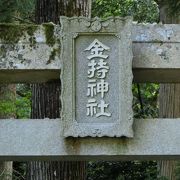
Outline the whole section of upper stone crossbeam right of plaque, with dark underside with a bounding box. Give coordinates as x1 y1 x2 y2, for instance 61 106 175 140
133 24 180 83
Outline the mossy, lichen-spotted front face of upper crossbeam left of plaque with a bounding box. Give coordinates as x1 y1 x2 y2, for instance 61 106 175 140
0 24 61 70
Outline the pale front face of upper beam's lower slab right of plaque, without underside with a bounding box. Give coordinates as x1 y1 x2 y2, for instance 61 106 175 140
133 42 180 69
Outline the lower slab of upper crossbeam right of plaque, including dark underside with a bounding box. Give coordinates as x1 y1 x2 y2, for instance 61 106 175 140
133 42 180 83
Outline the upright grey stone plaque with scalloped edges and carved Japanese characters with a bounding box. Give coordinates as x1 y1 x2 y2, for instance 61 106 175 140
60 17 133 137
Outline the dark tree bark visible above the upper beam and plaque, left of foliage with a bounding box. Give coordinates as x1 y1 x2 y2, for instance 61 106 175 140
36 0 91 24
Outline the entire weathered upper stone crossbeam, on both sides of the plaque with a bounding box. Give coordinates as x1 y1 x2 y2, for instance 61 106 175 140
0 23 180 83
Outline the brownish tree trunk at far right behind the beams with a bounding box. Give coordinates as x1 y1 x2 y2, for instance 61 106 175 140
158 1 180 180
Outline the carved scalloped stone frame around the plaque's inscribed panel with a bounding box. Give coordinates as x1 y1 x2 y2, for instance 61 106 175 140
60 16 133 138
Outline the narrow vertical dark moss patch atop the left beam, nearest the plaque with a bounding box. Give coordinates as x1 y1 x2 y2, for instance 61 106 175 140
43 23 56 46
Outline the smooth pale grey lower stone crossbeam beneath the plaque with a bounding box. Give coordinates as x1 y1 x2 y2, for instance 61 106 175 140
0 119 180 161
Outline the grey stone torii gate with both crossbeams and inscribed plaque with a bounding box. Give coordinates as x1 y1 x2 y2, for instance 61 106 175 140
0 17 180 161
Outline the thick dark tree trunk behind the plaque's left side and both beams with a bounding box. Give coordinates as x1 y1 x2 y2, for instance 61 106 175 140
26 0 91 180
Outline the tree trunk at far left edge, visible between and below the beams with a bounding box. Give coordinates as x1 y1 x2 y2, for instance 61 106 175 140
0 85 16 180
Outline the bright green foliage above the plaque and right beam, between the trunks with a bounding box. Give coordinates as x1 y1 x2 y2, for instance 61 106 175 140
92 0 159 22
